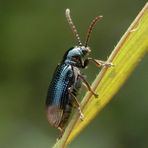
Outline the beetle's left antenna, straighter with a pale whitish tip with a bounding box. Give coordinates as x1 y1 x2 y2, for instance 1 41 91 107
65 9 82 46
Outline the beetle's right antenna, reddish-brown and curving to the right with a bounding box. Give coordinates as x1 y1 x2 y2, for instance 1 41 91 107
84 16 103 47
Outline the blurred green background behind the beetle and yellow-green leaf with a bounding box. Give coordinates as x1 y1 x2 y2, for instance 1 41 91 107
0 0 148 148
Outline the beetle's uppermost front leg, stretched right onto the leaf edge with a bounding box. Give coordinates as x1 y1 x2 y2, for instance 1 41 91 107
88 58 114 67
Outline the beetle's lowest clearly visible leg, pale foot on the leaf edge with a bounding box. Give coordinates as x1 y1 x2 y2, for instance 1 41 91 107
68 88 84 120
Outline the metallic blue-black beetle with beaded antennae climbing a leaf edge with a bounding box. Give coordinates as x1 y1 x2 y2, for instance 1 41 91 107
46 9 112 132
